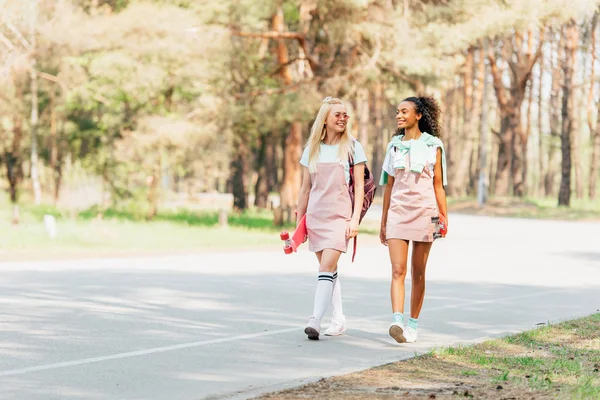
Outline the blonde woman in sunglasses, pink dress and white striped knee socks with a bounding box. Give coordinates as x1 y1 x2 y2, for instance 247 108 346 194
297 97 367 340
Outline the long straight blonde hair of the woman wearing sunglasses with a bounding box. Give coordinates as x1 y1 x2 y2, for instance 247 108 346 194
306 97 355 173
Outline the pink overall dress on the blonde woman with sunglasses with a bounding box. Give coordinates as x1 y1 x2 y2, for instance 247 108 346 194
306 162 352 253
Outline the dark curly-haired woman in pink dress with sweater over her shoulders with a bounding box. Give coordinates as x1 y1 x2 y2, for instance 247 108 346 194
379 97 448 343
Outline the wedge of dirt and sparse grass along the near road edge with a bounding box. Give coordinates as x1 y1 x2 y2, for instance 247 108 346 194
252 314 600 400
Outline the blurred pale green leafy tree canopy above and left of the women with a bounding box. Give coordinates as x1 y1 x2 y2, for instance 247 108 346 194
0 0 599 216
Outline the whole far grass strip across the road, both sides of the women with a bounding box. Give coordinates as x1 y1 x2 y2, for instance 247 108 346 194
0 191 600 260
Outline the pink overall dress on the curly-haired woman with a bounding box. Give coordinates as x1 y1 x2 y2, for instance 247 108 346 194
386 154 438 242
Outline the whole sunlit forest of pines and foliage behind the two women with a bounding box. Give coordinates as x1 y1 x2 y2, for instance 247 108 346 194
0 0 600 244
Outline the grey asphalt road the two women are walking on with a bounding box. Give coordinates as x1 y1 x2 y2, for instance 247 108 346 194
0 215 600 400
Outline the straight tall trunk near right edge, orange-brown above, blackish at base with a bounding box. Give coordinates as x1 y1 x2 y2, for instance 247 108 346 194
558 19 579 206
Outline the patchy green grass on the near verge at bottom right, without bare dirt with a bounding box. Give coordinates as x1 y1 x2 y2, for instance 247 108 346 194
436 313 600 399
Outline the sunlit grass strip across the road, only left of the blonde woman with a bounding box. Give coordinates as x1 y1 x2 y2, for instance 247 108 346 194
0 202 304 259
